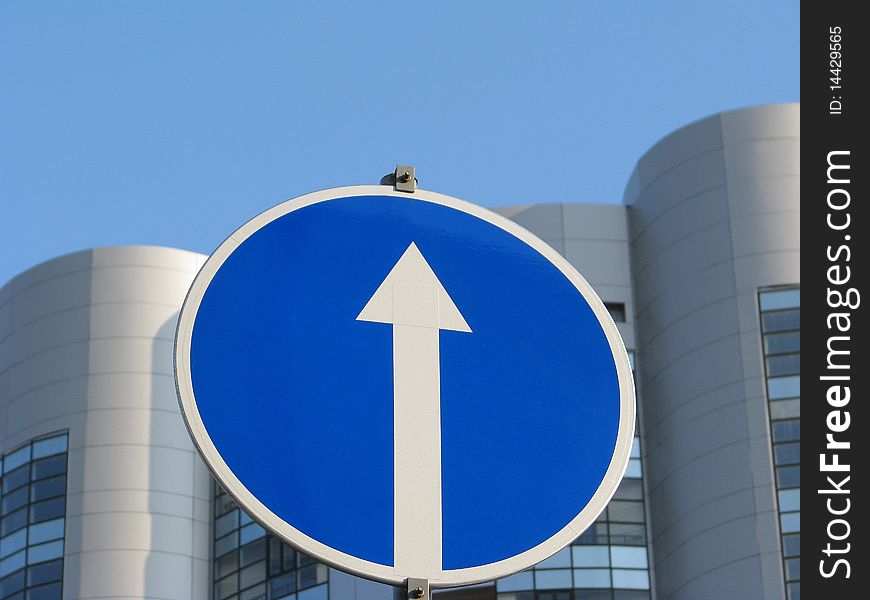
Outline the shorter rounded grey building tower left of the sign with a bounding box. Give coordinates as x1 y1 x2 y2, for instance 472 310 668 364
0 246 212 600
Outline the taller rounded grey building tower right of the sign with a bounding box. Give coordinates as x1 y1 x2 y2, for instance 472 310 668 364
625 104 800 600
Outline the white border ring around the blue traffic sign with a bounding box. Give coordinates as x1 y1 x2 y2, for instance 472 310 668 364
173 185 635 587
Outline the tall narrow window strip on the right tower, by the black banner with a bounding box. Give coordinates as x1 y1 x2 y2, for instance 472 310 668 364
758 286 801 600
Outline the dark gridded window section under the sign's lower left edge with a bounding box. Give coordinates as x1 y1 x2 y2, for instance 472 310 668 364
214 483 329 600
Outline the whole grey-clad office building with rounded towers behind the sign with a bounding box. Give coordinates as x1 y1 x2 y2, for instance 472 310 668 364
0 104 800 600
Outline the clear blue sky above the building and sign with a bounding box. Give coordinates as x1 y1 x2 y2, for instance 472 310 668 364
0 0 799 284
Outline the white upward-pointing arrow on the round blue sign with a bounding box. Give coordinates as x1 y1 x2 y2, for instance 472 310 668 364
357 243 471 578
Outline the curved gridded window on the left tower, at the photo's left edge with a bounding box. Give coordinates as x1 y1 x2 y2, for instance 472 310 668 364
0 433 68 600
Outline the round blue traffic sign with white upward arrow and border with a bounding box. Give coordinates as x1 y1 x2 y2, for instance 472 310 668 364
176 186 634 586
